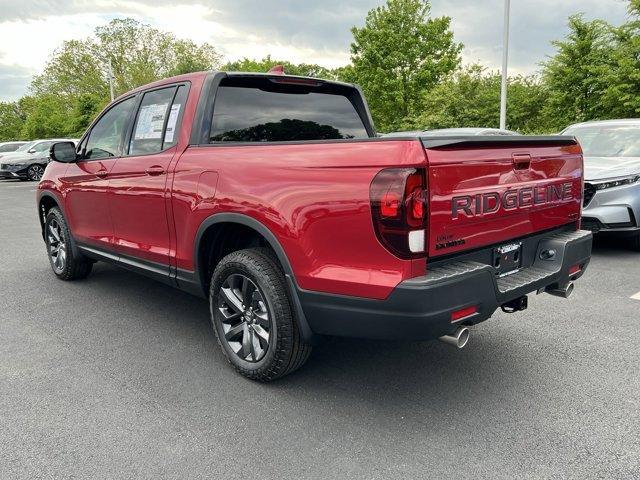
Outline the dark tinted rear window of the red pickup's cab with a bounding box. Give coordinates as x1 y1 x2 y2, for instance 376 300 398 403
210 86 368 142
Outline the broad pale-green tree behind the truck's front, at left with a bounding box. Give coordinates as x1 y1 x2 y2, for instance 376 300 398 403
21 18 221 138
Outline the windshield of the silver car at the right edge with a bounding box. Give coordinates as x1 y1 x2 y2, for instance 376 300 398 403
563 125 640 157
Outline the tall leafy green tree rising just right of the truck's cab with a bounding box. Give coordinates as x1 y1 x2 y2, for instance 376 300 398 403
348 0 462 131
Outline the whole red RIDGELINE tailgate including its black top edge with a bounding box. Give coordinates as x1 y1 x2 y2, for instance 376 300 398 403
422 136 583 257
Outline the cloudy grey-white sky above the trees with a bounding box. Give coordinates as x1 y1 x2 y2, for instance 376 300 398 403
0 0 627 100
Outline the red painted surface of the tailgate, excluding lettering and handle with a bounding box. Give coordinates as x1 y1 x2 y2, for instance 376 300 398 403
427 146 582 256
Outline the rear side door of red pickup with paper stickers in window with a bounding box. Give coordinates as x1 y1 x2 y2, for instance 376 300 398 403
109 85 188 268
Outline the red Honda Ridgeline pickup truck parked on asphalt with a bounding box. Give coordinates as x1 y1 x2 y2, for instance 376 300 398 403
37 71 591 381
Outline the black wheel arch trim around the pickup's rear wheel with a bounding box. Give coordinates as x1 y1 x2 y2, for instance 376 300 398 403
190 213 318 344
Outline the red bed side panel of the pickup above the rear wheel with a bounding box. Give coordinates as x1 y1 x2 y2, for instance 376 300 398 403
172 139 425 298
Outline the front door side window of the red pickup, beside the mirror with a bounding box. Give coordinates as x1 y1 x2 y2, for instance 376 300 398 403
84 97 136 159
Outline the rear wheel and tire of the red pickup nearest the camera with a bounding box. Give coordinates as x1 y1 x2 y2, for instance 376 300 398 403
209 248 312 382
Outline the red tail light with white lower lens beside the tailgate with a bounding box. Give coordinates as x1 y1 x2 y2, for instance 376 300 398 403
369 168 427 259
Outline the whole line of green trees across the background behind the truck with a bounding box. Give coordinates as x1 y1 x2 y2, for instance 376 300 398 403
0 0 640 141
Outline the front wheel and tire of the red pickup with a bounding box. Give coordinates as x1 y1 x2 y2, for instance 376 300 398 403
44 207 93 280
